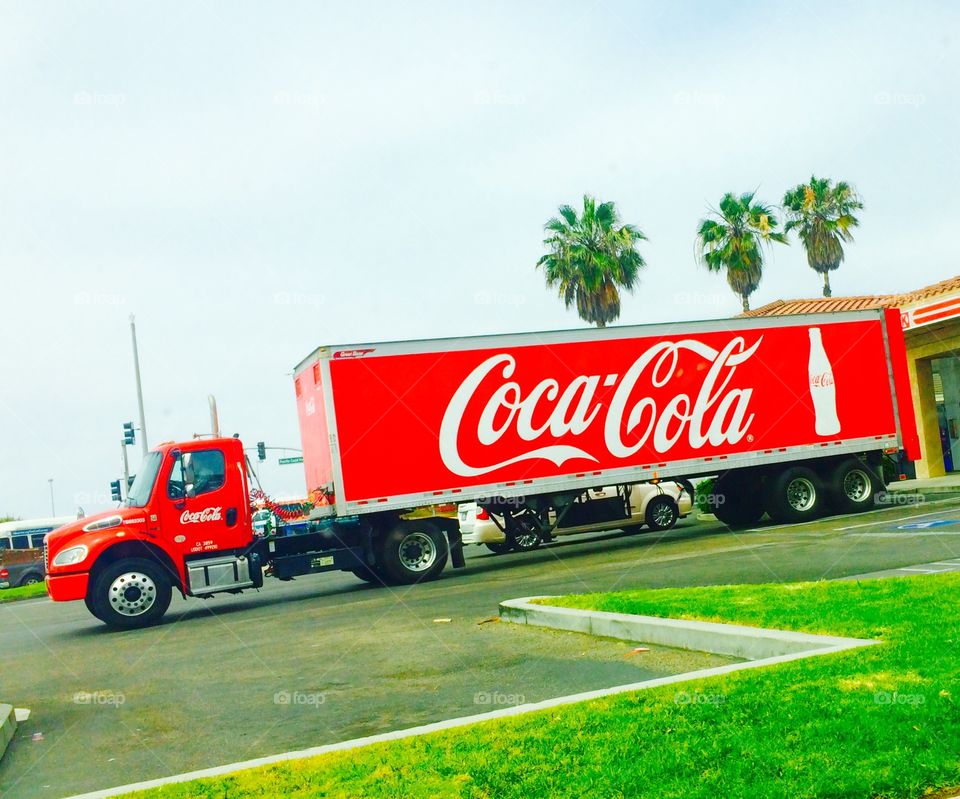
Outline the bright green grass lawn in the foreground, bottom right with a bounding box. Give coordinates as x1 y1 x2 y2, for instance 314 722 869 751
124 574 960 799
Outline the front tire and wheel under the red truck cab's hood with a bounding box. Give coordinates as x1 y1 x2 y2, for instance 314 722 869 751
87 558 172 630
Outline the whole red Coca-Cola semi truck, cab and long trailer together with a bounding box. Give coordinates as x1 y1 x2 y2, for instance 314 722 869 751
45 311 918 628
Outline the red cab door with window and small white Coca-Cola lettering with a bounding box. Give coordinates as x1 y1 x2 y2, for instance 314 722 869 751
160 446 251 556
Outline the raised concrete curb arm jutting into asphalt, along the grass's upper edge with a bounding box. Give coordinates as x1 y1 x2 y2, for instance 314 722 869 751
500 597 877 660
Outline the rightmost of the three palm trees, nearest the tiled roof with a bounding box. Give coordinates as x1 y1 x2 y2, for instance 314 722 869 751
783 176 863 297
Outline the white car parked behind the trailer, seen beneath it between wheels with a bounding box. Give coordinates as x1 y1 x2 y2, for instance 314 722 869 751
457 480 693 554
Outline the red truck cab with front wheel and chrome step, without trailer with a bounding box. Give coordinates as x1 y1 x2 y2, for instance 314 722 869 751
45 438 262 627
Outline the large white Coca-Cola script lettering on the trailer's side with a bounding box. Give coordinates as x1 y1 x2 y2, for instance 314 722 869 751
440 336 763 477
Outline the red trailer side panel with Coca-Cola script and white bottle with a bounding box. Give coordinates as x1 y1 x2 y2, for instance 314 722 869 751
330 320 895 502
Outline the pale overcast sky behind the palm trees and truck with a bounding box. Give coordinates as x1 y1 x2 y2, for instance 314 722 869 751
0 0 960 518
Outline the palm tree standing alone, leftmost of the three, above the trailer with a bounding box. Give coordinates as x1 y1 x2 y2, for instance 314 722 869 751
537 194 647 327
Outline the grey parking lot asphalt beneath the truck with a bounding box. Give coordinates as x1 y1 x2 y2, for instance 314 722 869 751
0 499 960 799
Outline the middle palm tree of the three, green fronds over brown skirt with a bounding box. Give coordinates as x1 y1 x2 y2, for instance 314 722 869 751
697 192 787 311
